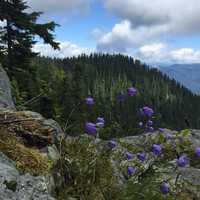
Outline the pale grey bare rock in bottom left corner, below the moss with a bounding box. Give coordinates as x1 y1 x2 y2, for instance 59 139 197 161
0 154 55 200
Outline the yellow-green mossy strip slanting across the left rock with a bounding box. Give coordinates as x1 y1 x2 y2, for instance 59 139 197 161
0 128 52 176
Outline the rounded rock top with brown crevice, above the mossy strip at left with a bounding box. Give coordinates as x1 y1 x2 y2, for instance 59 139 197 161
0 110 63 149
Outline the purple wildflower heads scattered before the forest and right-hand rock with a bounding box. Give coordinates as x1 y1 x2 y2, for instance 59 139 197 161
81 87 200 195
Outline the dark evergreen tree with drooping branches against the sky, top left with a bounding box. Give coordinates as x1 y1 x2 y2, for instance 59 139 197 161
0 0 59 72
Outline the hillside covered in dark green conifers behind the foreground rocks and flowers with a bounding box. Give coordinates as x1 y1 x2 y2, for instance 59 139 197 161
10 54 200 137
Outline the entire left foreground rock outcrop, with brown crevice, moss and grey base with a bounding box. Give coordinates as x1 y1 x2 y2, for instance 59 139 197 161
0 109 63 200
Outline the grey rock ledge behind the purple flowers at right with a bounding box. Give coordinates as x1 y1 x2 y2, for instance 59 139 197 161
111 129 200 199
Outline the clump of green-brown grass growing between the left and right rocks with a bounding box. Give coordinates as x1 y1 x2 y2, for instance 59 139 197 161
57 136 119 200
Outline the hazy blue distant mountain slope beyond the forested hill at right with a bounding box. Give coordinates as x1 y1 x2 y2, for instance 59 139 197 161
159 63 200 94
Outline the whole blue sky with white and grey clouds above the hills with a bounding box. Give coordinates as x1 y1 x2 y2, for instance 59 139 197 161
27 0 200 64
